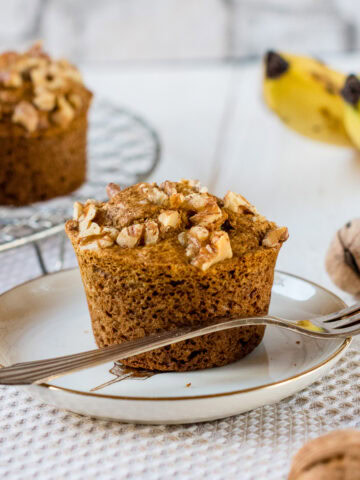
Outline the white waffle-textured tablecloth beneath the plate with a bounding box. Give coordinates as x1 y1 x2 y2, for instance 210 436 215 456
0 239 360 480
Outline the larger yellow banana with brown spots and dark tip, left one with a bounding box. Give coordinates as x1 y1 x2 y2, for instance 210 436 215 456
264 51 352 146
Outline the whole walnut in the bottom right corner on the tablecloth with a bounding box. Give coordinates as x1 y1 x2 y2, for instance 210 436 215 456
289 430 360 480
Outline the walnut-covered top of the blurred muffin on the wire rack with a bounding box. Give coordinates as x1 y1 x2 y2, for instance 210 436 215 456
0 43 92 135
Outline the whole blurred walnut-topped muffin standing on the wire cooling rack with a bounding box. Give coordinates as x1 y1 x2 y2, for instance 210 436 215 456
0 43 92 206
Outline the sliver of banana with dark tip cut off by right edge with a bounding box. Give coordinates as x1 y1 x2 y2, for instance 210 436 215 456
341 75 360 150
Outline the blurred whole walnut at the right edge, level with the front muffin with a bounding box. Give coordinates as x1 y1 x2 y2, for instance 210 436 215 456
325 218 360 296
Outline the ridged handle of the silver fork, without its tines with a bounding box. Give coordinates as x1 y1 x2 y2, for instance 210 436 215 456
0 316 276 385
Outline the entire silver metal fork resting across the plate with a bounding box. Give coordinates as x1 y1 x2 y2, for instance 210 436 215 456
0 303 360 385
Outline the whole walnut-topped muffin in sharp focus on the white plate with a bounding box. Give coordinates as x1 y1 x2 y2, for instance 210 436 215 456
66 180 288 371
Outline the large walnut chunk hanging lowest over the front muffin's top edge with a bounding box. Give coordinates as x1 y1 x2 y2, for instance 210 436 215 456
191 231 232 271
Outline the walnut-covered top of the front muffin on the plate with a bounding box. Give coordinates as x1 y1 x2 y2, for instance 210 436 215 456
67 180 288 271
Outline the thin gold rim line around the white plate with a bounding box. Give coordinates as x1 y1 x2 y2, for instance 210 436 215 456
0 268 351 402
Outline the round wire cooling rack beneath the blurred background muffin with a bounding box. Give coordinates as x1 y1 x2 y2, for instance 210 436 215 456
0 100 160 255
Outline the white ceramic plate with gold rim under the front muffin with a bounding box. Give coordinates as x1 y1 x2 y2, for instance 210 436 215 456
0 270 350 424
